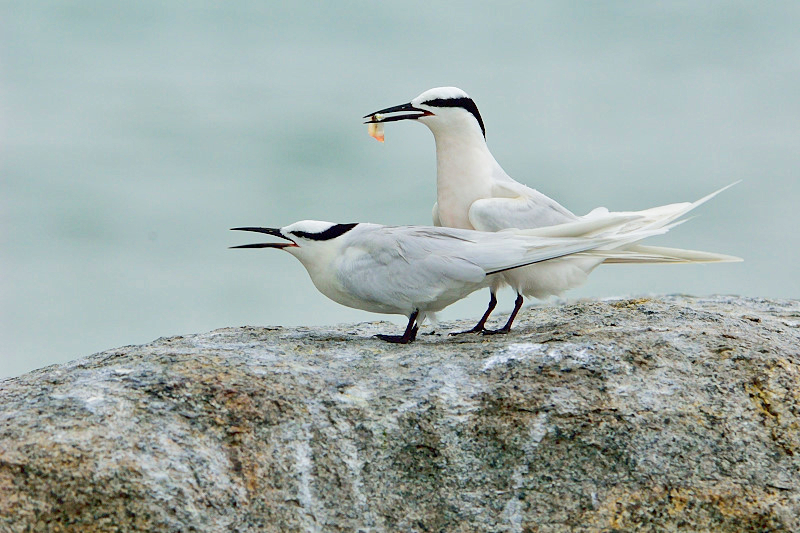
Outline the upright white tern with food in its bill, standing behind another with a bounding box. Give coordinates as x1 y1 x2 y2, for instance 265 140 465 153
364 87 741 334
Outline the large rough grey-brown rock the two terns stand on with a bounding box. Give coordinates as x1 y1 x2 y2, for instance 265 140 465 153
0 296 800 532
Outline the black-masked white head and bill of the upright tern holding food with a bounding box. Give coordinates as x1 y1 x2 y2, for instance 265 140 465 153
364 87 486 139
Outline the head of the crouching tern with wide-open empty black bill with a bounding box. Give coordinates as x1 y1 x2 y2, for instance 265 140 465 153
231 220 358 261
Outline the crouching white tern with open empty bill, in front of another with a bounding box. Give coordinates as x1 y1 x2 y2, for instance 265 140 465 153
232 215 669 343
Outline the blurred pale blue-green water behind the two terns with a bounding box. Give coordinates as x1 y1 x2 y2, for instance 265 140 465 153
0 0 800 377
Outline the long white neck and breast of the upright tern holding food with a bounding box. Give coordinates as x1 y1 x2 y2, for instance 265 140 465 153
432 128 502 229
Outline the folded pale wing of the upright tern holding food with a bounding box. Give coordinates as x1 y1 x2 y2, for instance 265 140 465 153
469 182 578 231
